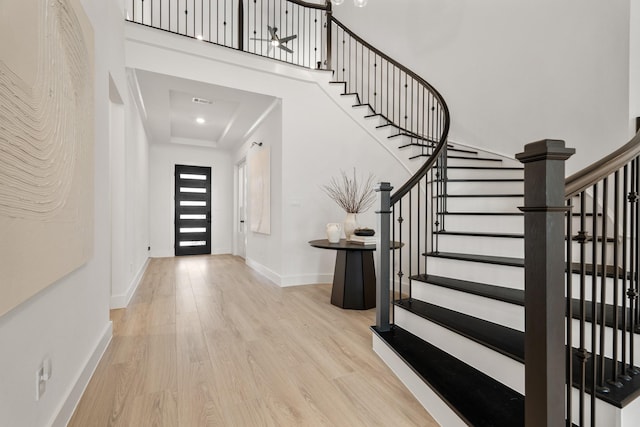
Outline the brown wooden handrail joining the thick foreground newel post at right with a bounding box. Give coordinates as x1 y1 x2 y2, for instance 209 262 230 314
564 130 640 199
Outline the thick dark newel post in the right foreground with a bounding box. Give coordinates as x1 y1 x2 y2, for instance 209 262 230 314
516 139 575 427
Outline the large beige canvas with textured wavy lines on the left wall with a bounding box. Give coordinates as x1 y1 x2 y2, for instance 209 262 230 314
0 0 94 316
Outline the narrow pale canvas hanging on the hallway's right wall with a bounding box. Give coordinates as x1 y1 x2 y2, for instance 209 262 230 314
248 146 271 234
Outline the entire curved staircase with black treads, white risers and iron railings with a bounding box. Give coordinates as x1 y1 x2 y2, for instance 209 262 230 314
128 0 640 427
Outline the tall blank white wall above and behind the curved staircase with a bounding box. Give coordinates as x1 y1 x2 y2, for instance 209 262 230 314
334 0 637 172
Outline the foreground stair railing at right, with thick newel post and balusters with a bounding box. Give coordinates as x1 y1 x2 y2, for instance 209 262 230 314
517 120 640 427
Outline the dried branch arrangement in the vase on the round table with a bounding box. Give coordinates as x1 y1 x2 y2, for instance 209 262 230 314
322 169 376 213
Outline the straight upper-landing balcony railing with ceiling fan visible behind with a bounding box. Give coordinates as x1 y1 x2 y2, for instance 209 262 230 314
126 0 331 69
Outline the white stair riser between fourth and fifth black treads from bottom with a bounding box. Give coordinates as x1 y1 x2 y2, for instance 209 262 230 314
436 234 524 258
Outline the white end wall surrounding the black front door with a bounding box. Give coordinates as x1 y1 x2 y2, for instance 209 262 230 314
149 143 233 257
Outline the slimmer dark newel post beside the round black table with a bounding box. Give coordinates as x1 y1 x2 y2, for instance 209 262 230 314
375 182 393 331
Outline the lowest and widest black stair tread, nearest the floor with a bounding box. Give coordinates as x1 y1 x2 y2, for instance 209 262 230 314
372 326 524 427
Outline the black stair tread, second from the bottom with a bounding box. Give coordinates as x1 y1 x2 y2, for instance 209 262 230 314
396 299 524 363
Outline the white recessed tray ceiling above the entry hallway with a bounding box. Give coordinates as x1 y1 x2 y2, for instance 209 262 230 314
129 70 276 149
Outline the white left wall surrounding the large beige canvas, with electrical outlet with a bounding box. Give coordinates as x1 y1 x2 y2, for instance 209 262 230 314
0 1 126 426
